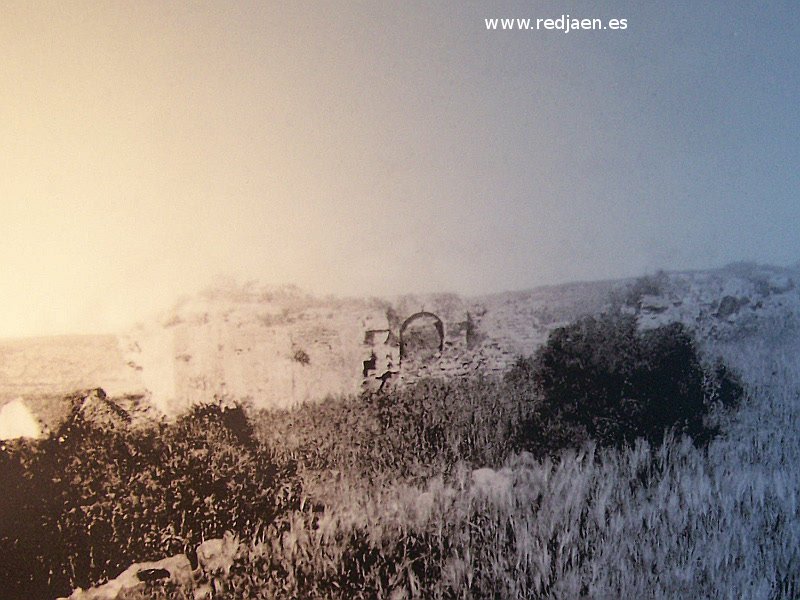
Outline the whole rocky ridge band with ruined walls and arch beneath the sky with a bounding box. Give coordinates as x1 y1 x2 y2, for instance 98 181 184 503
0 263 800 436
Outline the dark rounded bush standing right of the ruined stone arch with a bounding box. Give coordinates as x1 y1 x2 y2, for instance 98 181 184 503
507 312 742 454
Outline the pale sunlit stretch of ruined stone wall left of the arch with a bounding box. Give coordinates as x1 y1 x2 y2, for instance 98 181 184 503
125 302 394 413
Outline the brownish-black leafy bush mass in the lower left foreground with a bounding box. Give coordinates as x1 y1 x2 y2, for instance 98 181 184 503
0 398 299 598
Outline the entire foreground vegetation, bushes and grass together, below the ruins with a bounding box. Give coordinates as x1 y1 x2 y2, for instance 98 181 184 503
0 304 800 600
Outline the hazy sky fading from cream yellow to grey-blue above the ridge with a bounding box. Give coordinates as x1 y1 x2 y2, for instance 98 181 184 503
0 0 800 337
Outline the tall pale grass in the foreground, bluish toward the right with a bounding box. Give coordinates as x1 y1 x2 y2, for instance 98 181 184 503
231 336 800 600
